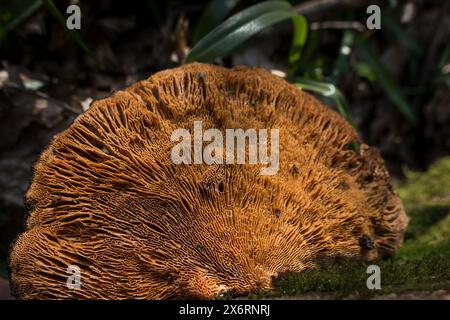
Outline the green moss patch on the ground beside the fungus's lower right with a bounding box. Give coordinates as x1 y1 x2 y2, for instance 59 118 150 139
249 157 450 299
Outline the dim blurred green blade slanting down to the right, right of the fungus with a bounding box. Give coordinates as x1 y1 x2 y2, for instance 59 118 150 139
358 38 418 124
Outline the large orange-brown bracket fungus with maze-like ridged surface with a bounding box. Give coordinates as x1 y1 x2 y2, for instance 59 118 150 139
9 63 408 299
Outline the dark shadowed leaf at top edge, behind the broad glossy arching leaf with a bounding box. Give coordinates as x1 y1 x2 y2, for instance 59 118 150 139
192 0 243 44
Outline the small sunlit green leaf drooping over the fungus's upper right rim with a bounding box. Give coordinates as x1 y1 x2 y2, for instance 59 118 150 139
294 78 354 125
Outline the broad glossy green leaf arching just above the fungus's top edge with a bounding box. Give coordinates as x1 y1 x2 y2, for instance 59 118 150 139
185 1 306 63
